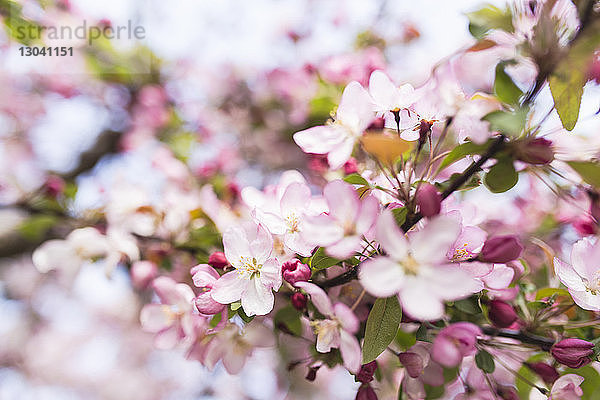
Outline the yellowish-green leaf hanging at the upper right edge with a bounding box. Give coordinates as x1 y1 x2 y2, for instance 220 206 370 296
548 21 600 131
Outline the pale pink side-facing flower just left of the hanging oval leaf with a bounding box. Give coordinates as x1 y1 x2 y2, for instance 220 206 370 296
296 282 361 373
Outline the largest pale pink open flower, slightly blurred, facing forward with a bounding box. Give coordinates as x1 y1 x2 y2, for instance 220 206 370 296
359 210 482 320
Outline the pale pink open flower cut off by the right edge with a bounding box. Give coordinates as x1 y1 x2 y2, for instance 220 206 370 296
554 238 600 311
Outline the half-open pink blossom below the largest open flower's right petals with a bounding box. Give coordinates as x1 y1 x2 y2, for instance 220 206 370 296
431 322 482 368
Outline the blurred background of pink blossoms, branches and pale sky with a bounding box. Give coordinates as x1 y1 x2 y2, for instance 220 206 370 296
0 0 597 400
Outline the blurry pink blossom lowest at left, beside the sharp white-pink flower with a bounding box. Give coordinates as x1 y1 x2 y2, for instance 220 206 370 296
140 276 200 349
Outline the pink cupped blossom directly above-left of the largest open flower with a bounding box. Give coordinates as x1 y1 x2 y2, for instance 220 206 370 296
303 180 379 260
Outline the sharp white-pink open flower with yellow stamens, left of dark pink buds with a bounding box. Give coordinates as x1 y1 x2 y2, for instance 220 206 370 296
211 224 281 316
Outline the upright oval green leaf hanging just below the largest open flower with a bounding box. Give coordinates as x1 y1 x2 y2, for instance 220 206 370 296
363 296 402 364
